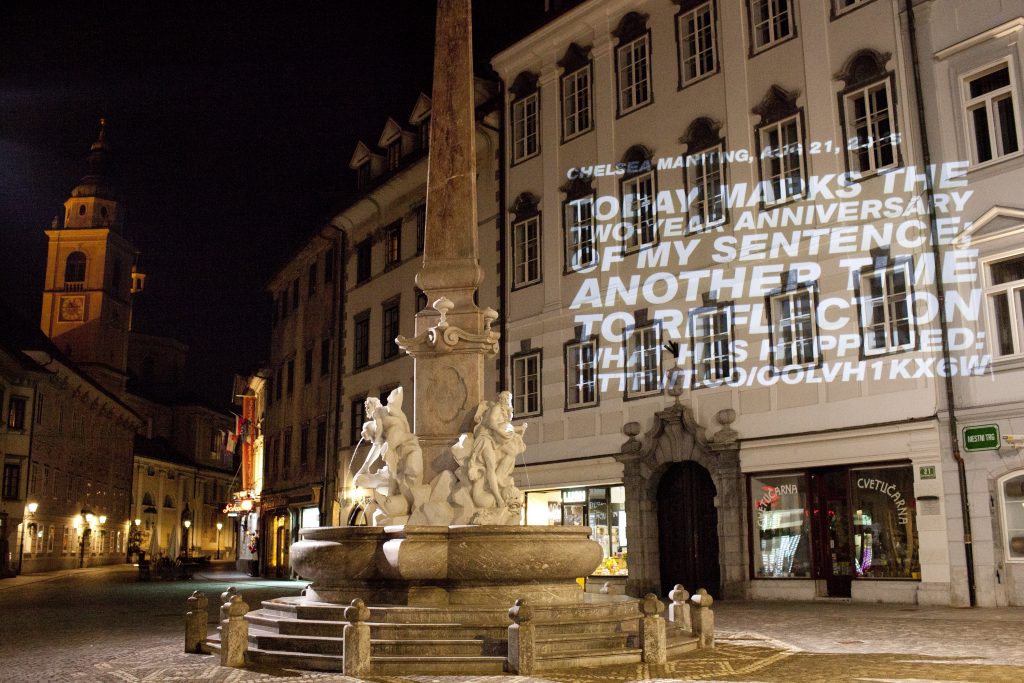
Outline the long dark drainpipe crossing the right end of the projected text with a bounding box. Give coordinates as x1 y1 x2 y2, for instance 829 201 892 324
904 0 978 607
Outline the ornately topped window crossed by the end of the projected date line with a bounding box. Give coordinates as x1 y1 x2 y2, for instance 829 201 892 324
843 78 897 175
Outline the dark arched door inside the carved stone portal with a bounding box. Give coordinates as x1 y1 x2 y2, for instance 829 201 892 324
657 461 722 597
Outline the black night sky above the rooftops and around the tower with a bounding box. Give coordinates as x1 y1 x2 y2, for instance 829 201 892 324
0 0 544 404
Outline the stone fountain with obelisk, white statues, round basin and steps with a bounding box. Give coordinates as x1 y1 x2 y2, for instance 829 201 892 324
202 0 710 675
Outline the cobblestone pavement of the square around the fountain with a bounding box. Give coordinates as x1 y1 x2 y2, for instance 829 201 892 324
0 566 1024 683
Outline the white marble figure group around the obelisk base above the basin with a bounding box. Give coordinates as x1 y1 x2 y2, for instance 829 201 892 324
352 387 526 526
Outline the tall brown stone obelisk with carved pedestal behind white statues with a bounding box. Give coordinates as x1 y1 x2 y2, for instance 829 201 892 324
397 0 498 481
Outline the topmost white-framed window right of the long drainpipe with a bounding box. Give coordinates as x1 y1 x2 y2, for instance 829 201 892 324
963 61 1021 164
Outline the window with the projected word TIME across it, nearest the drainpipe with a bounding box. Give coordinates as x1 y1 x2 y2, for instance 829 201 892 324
857 258 916 355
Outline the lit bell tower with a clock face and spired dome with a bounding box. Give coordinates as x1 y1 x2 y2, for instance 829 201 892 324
40 119 145 396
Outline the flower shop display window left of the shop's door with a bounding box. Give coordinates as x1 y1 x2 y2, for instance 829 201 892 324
751 474 811 579
